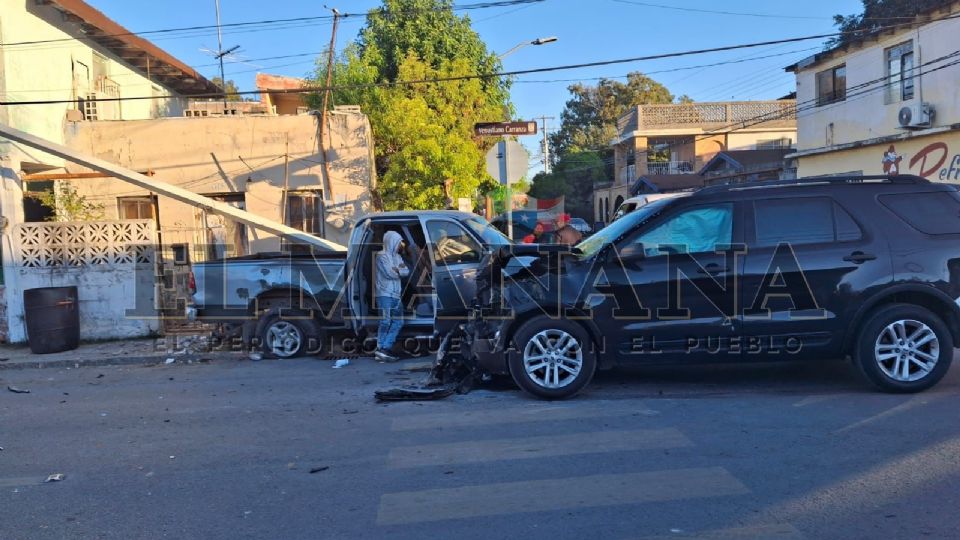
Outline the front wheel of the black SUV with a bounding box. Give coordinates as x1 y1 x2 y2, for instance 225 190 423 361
508 317 597 399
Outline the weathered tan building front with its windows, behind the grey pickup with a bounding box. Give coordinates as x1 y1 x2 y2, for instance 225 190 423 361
66 108 376 261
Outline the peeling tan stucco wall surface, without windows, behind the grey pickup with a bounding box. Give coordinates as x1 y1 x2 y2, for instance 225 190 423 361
66 112 375 252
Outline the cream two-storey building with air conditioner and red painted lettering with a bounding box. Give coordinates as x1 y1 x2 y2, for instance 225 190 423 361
787 1 960 182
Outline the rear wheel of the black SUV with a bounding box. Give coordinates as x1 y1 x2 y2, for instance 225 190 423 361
856 304 953 393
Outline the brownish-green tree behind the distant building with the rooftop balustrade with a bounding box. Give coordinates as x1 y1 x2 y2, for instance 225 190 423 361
550 72 673 158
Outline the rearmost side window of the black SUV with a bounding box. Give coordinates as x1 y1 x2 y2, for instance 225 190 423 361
880 191 960 234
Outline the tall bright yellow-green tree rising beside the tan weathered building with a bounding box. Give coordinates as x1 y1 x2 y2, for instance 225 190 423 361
308 0 511 209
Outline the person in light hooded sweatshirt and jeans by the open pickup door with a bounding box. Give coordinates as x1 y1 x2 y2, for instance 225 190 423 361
374 231 410 362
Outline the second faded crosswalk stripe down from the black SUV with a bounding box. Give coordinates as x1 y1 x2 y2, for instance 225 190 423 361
387 429 693 468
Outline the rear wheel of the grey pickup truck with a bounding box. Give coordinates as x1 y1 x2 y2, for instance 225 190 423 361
256 309 322 358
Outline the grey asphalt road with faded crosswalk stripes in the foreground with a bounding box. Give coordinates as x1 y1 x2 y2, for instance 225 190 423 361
0 354 960 539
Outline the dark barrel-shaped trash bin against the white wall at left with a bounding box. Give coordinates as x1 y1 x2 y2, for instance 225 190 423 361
23 287 80 354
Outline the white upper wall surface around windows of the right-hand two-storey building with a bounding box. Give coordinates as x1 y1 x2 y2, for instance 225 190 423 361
797 3 960 153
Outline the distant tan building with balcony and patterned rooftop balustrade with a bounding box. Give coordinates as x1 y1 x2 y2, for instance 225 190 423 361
594 99 797 223
